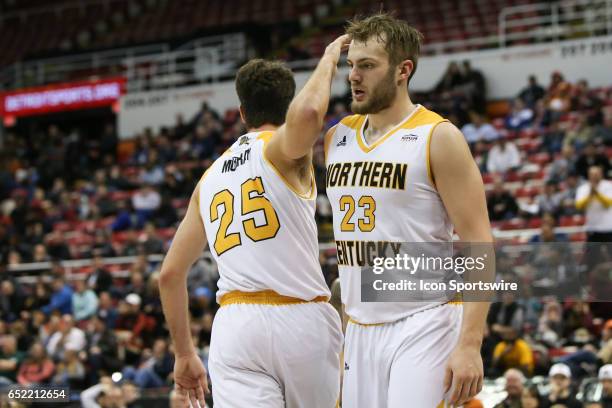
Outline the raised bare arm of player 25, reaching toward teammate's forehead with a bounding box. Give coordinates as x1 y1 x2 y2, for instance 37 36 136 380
265 35 349 187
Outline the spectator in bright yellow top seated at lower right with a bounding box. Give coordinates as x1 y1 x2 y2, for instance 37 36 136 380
493 329 534 375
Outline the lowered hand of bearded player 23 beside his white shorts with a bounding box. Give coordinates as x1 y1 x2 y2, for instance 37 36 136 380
444 346 484 406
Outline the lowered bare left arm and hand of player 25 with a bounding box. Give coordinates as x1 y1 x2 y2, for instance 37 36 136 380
159 184 208 407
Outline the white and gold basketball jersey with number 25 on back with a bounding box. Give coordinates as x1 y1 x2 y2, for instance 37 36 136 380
199 132 330 302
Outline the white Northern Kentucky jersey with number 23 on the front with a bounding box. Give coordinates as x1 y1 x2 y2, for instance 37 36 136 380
325 105 453 324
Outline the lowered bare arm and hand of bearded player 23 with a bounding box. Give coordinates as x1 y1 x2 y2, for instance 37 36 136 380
430 122 493 405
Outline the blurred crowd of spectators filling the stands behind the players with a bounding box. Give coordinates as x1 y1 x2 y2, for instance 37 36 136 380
0 1 612 408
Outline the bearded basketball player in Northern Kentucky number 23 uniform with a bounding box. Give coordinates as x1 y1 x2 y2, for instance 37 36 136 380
325 14 492 408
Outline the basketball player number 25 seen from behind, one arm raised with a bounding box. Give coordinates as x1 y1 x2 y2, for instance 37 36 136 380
160 36 348 408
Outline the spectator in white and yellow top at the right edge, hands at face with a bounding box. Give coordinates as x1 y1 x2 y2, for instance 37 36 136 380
576 166 612 242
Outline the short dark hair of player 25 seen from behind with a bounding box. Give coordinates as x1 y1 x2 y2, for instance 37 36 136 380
236 59 295 128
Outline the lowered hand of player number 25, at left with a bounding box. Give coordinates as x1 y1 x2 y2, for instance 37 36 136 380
174 353 210 408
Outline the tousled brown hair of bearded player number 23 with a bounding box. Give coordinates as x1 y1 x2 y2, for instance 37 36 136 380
346 13 423 81
